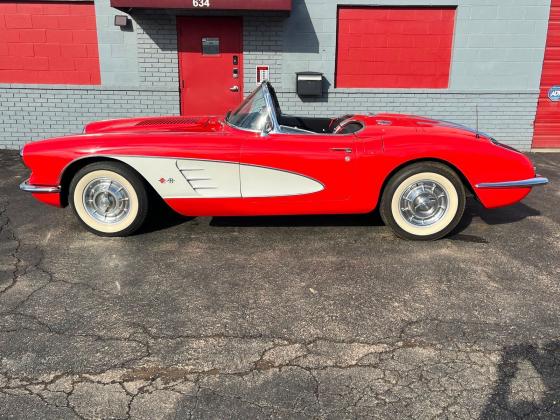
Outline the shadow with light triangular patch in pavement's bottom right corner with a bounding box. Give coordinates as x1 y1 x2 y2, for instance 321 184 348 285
480 341 560 419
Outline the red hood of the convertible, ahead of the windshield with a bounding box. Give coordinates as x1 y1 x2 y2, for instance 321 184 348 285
84 116 223 134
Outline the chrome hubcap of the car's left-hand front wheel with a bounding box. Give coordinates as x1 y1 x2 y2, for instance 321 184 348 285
83 178 130 224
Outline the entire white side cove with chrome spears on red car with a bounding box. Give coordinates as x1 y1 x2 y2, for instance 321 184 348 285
110 156 324 198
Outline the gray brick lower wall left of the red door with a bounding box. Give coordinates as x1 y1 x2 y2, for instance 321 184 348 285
0 85 179 149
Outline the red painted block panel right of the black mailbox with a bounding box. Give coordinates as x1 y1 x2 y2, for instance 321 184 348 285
336 7 455 88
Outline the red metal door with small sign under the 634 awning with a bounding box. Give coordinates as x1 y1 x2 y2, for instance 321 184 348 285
177 17 243 115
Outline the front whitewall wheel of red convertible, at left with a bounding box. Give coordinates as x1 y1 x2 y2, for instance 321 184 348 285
69 162 149 236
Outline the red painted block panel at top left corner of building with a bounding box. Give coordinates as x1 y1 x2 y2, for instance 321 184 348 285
0 2 101 85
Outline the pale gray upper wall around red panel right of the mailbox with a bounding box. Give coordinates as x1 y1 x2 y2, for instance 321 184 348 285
282 0 550 91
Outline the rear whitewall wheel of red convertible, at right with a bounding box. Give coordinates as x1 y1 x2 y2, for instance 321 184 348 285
380 162 466 241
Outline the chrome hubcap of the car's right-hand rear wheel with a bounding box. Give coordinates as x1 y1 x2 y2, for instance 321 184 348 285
400 180 449 226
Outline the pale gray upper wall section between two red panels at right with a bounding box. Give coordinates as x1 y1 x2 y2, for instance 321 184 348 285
450 0 550 90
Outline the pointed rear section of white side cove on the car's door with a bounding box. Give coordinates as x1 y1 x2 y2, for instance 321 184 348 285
240 165 324 197
